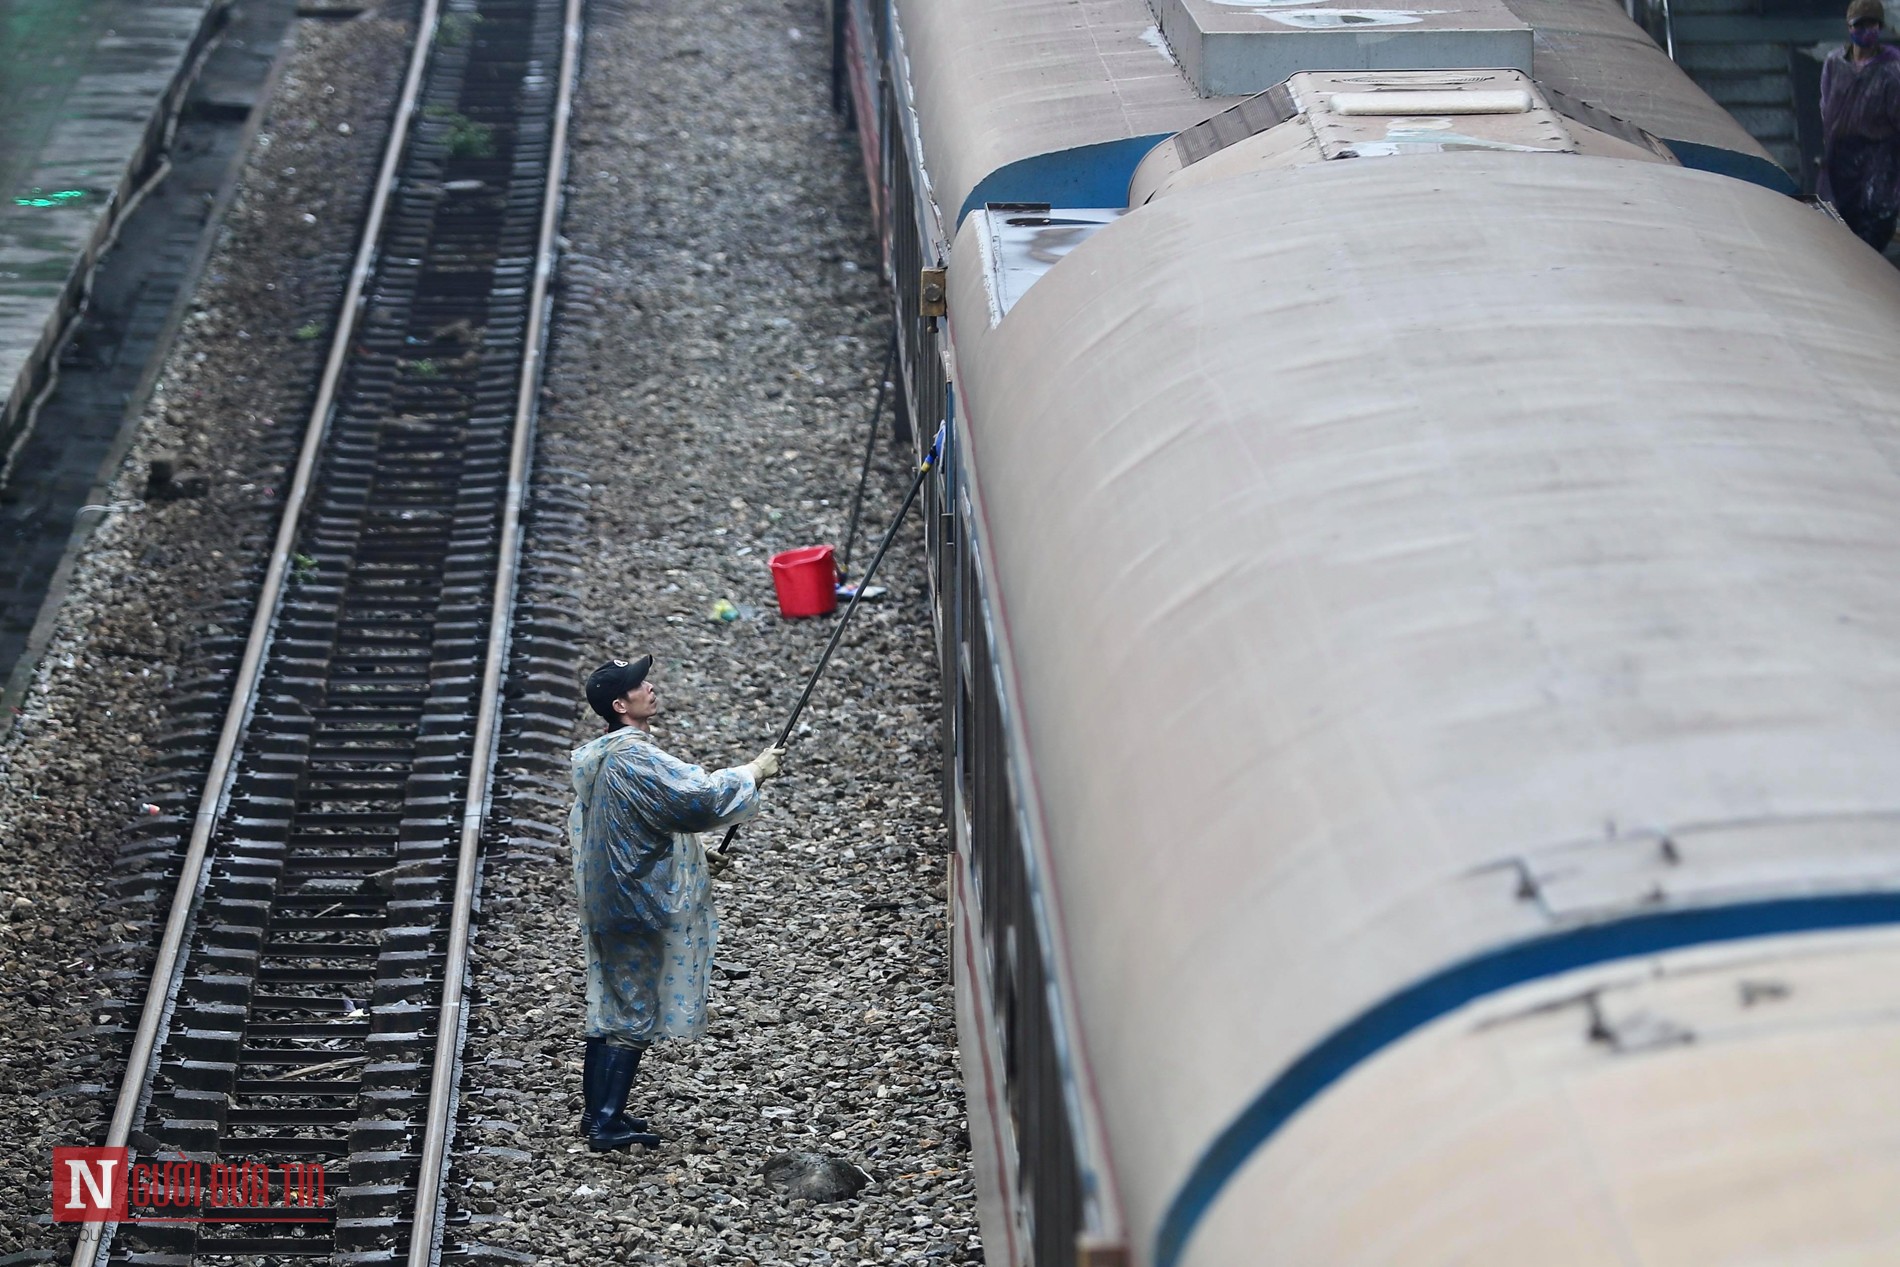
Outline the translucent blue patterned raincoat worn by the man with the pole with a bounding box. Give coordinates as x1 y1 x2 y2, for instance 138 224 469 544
568 726 758 1045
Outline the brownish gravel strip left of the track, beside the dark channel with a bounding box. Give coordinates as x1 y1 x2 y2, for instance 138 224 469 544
0 13 409 1256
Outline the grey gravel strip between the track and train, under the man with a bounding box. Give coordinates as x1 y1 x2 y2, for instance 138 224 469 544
450 0 980 1263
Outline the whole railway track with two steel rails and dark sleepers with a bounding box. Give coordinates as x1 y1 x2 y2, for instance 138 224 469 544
72 0 580 1267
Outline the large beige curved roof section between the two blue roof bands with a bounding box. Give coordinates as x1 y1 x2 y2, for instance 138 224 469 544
950 152 1900 1261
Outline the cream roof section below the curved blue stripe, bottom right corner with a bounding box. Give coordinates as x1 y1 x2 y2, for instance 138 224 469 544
1189 927 1900 1267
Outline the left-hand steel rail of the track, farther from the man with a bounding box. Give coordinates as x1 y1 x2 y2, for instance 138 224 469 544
72 0 439 1267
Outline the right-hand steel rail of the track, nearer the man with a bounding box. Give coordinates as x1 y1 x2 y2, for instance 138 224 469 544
409 0 581 1267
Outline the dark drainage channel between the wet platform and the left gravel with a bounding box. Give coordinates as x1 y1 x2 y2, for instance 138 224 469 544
0 0 296 702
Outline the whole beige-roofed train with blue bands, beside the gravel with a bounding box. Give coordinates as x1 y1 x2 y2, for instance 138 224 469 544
840 0 1900 1267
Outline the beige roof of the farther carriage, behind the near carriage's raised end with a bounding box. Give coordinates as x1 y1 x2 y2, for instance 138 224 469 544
895 0 1778 227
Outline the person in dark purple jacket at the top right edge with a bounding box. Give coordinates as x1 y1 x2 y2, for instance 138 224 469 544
1820 0 1900 251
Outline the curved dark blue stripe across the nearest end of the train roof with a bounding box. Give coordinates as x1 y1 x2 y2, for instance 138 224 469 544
1155 893 1900 1267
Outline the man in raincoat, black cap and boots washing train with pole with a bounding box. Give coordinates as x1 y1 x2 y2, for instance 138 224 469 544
568 655 785 1153
